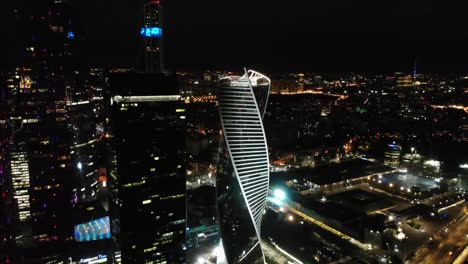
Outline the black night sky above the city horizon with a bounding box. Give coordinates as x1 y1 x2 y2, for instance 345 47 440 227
1 0 468 72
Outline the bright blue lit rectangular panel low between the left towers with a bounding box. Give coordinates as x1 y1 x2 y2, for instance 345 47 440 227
74 216 111 242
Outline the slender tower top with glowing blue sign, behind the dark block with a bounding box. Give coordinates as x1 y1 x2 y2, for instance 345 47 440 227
140 0 164 72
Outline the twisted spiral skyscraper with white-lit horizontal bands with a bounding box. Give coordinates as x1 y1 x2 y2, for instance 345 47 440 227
216 70 270 264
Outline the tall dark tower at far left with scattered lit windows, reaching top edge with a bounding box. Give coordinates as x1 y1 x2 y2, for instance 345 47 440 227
9 0 75 246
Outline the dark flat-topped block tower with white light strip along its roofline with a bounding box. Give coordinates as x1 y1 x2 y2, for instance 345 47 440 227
109 73 186 263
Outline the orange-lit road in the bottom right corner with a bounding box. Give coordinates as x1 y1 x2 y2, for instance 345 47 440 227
409 208 468 264
